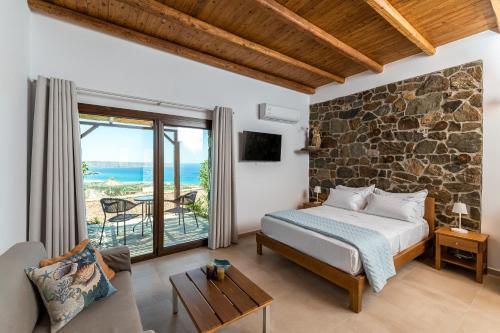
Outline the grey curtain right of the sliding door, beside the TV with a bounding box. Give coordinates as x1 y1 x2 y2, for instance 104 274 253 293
208 107 238 249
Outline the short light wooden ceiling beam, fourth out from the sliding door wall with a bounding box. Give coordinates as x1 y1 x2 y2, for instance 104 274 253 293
365 0 436 55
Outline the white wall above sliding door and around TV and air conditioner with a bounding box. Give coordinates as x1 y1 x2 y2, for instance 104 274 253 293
31 14 309 232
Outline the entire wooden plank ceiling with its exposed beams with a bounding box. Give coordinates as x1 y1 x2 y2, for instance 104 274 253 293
28 0 499 93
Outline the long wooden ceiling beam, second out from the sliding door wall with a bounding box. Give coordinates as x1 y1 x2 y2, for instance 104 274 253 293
119 0 345 83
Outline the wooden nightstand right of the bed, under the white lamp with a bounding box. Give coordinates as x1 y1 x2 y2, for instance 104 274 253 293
436 227 488 283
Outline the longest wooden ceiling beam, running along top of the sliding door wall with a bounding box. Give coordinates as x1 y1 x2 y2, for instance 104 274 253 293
28 0 315 94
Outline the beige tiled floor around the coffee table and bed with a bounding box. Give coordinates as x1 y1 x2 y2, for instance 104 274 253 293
132 237 500 333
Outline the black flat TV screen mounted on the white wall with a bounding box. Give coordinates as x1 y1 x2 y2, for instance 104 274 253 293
241 131 281 162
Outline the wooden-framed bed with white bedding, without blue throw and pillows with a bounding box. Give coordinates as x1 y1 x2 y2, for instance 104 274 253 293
256 197 435 312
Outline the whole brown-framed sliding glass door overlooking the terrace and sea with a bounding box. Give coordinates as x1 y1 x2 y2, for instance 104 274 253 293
79 104 211 261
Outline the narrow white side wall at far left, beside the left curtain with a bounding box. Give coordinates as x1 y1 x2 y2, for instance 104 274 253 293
0 0 30 253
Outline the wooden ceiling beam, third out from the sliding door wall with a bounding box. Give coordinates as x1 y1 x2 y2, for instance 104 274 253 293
254 0 384 73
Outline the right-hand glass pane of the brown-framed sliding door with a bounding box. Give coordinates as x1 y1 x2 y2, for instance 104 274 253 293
162 126 209 248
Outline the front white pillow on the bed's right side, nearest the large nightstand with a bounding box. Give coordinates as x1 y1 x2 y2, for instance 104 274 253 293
363 193 422 223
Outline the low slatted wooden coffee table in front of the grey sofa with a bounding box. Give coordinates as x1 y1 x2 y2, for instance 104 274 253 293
170 266 273 332
